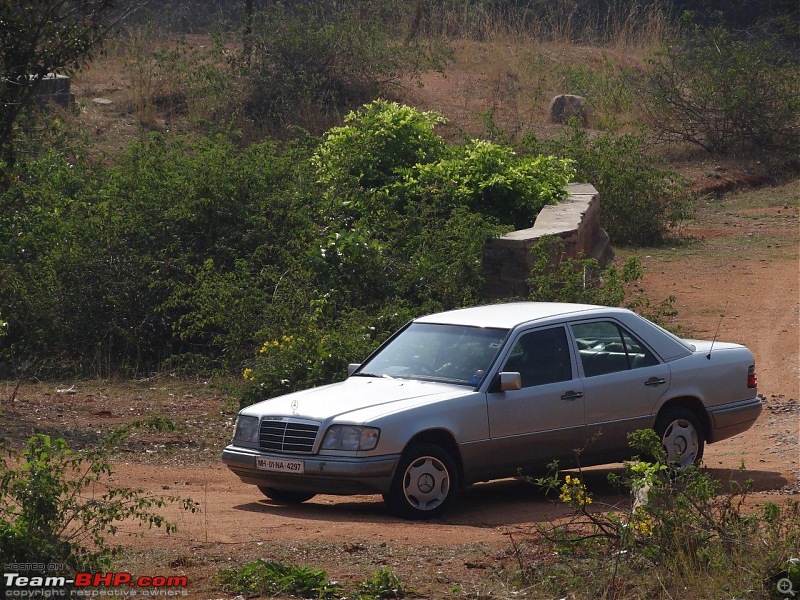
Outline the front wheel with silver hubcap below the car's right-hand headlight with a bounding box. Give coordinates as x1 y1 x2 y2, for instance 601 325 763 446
384 443 459 520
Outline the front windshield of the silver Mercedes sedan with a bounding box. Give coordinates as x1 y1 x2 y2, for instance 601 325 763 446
356 323 508 386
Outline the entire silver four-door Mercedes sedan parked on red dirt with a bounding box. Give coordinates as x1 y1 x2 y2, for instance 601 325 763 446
222 302 762 518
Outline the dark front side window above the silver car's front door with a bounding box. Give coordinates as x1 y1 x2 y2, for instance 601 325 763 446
502 327 572 388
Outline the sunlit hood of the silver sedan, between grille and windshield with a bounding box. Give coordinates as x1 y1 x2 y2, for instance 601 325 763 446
241 376 473 423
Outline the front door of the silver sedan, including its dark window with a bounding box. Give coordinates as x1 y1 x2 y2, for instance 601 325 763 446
487 325 585 475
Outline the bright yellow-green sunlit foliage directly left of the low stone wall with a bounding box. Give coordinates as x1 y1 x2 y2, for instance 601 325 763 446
314 100 572 226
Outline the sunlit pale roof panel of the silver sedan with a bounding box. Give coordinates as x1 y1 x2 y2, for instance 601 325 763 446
415 302 612 329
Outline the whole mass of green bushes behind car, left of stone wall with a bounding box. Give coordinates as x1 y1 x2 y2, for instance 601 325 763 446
0 101 572 380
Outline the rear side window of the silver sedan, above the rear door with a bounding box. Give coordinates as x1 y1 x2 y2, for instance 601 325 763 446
572 321 658 377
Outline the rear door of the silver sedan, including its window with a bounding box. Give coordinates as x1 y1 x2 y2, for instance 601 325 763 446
570 319 670 463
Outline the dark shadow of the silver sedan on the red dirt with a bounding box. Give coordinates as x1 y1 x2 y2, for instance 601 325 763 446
234 466 787 527
